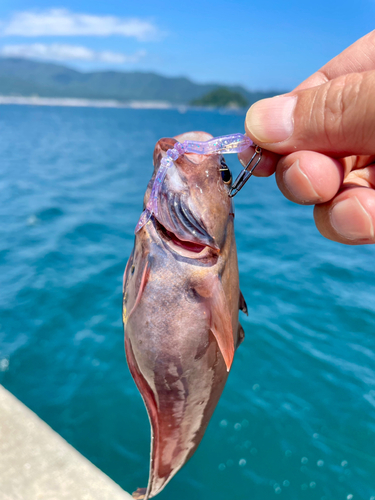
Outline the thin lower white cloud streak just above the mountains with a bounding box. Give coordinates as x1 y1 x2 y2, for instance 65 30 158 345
0 43 146 64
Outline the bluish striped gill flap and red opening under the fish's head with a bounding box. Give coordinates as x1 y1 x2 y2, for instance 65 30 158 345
155 191 219 256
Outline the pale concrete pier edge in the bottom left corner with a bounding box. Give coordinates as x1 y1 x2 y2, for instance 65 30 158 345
0 385 132 500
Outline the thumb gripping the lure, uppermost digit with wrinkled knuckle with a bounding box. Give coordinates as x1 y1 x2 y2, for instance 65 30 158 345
245 71 375 157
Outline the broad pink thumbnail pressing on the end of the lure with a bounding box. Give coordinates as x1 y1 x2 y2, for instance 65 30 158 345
246 96 297 143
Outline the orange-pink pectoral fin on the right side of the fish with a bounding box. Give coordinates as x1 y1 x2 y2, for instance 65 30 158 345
196 276 234 372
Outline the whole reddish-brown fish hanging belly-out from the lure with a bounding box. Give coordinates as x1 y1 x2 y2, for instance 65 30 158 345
123 132 247 500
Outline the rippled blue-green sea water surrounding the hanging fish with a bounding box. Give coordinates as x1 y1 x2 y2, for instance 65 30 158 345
0 106 375 500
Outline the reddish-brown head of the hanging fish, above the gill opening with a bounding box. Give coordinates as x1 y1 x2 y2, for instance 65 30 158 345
144 132 233 253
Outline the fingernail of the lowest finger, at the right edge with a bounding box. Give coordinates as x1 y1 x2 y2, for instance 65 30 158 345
330 196 374 240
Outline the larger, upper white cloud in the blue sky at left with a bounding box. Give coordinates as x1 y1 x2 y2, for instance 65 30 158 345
0 9 161 40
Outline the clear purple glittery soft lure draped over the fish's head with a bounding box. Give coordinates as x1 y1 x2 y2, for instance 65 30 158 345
134 134 254 233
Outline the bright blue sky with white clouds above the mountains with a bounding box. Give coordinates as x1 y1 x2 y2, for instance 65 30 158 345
0 0 375 91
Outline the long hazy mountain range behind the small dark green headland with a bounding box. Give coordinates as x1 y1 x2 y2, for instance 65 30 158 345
0 58 280 104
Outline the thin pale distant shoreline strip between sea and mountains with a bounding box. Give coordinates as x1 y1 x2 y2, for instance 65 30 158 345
0 95 244 114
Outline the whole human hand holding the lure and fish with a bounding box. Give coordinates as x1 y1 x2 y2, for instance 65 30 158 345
239 31 375 245
